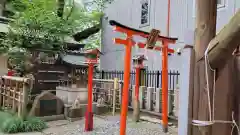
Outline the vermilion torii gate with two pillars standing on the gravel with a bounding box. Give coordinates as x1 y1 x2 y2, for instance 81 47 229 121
109 20 177 135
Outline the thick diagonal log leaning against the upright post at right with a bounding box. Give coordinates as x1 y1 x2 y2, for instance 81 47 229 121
208 10 240 68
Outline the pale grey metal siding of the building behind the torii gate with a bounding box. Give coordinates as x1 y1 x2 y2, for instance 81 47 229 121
101 0 236 70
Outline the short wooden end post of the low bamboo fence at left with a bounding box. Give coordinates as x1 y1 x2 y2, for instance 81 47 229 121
20 82 29 120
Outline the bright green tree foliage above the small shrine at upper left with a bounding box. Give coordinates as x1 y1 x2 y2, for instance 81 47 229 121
0 0 113 75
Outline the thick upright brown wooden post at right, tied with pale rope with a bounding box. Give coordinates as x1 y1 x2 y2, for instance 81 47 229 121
192 0 217 135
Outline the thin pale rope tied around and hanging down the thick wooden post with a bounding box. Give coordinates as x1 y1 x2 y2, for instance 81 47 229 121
192 45 240 135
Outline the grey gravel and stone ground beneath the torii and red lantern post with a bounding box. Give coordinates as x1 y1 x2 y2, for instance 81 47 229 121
0 116 177 135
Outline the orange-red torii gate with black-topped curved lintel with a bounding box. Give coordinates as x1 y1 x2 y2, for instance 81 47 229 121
109 20 177 135
